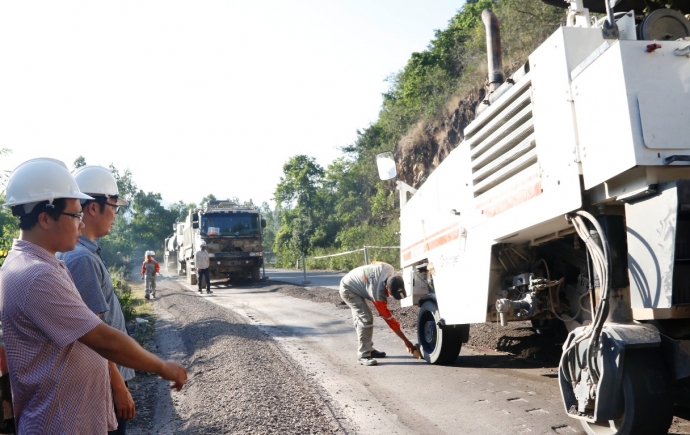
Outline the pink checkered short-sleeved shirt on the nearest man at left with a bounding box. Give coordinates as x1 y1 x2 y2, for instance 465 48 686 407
0 240 117 434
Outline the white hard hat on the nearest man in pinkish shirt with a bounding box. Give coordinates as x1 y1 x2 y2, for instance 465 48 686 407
5 157 93 213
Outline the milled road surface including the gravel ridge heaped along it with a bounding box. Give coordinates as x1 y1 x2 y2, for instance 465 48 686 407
129 279 688 434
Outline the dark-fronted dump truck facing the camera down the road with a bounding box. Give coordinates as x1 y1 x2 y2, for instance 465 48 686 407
175 200 266 285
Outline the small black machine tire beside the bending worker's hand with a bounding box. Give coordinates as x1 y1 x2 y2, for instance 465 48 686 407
417 301 462 365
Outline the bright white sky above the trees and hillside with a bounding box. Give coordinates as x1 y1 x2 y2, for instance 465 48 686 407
0 0 462 207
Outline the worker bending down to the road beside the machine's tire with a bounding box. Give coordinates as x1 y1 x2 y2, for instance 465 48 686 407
340 263 415 366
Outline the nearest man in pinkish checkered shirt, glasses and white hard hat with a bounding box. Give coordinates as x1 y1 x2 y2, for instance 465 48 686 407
0 158 187 434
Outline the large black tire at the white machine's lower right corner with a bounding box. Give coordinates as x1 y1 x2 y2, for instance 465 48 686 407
580 349 673 435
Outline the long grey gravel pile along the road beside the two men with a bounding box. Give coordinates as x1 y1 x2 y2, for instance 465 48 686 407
128 279 353 434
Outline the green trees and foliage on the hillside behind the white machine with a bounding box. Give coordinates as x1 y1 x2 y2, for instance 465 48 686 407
266 0 564 269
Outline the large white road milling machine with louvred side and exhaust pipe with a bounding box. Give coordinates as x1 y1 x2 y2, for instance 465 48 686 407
377 0 690 434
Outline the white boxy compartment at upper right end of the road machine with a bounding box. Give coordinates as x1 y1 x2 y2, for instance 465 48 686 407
573 41 690 189
